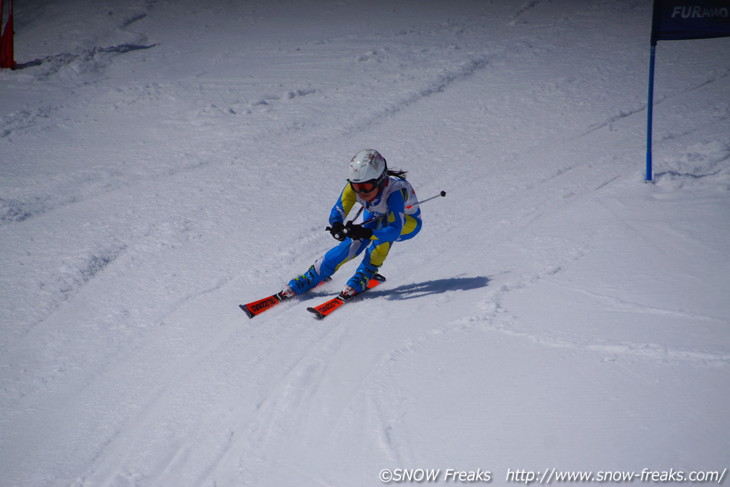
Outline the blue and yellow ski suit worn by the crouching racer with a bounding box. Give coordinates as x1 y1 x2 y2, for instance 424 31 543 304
289 176 421 294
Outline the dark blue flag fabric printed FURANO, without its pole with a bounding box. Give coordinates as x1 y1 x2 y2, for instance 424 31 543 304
651 0 730 46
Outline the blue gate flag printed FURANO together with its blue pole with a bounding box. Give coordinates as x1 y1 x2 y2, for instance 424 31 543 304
646 0 730 181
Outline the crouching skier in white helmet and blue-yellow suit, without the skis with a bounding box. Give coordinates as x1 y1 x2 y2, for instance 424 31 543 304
279 149 421 299
